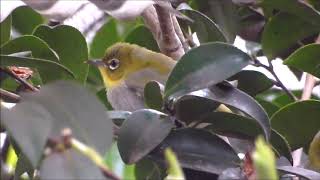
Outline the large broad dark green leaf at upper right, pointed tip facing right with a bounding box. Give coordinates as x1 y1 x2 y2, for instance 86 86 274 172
261 13 320 60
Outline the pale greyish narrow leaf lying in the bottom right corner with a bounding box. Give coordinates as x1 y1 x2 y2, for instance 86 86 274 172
277 166 320 180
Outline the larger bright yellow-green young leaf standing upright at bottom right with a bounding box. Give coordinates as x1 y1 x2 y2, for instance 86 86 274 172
252 137 278 180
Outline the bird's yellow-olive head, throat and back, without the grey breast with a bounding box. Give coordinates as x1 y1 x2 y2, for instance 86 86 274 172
88 43 175 88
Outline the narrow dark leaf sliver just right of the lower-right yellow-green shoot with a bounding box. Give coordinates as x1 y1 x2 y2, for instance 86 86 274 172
270 129 293 165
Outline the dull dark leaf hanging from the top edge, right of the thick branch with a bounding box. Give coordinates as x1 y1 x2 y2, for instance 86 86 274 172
191 0 239 43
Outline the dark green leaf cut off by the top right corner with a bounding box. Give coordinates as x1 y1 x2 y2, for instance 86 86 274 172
260 0 320 26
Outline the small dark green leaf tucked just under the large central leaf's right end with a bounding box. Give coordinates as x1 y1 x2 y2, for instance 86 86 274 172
229 70 273 96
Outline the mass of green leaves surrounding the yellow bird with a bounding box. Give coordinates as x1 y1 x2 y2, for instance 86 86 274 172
0 0 320 179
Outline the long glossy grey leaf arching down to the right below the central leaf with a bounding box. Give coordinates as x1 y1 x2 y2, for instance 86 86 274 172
185 83 271 139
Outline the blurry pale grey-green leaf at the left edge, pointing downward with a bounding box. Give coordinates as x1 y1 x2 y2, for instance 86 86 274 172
1 101 54 168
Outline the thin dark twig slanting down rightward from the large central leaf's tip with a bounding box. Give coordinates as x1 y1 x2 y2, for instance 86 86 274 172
254 58 298 101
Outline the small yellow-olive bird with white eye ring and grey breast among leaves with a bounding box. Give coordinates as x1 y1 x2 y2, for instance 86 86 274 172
88 42 176 111
